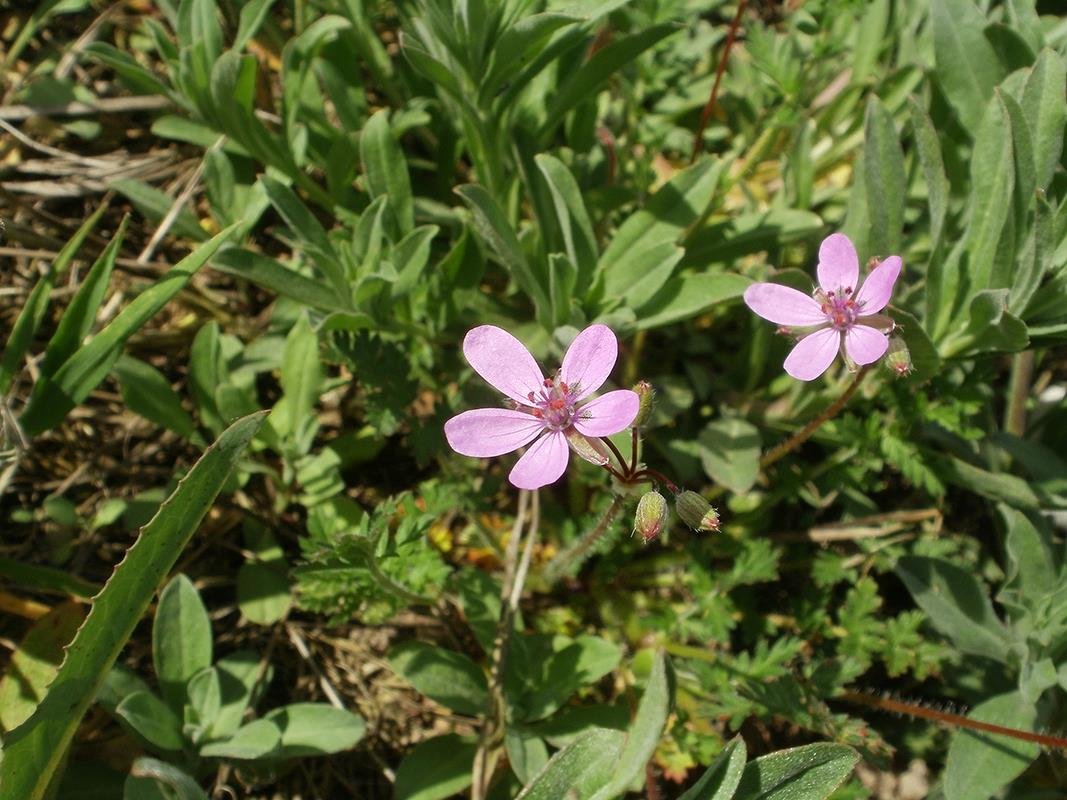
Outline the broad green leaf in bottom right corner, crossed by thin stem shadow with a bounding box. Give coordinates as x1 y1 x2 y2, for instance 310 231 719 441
942 691 1041 800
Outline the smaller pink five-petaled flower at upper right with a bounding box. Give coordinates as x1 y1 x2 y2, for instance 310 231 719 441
745 234 902 381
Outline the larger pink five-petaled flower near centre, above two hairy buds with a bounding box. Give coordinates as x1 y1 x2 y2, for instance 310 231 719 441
445 325 640 489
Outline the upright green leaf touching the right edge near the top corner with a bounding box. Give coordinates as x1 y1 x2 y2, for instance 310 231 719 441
1022 48 1067 189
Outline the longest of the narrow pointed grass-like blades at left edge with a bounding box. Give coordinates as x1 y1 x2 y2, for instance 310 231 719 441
19 228 232 436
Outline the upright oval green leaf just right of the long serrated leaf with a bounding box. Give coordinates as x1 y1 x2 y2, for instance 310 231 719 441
152 575 211 711
